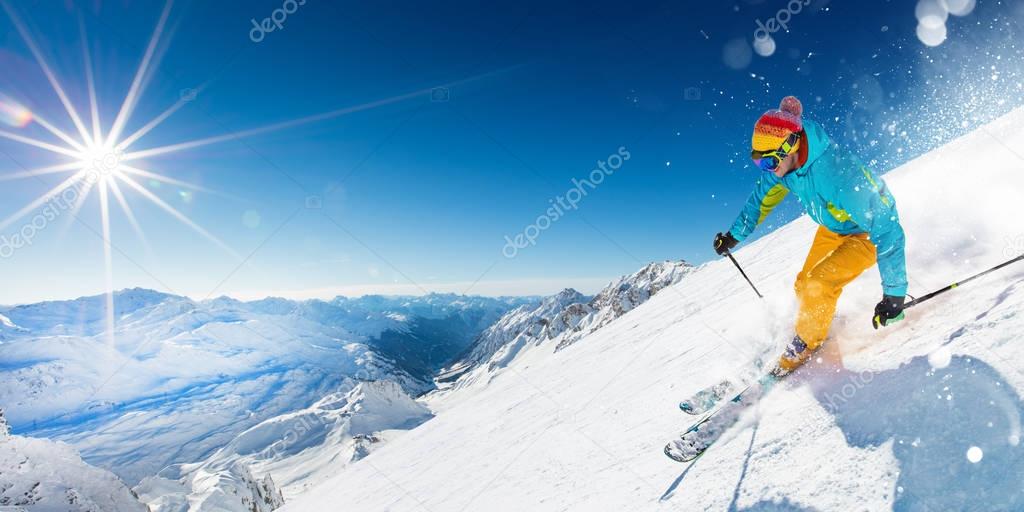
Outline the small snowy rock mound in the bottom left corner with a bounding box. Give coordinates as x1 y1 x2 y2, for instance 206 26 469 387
0 410 146 512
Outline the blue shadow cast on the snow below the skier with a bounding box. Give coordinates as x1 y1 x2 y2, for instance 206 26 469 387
660 355 1024 511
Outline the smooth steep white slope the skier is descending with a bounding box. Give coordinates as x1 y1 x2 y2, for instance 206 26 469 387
284 105 1024 512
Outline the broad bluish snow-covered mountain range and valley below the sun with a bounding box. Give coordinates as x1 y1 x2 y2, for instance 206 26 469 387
0 289 521 483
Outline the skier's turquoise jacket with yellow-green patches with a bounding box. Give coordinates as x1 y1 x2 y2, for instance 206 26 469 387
729 120 907 297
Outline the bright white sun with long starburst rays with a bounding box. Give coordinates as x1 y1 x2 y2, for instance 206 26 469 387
0 0 479 346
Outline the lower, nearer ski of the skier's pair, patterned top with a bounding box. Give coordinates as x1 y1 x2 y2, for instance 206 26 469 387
663 373 780 462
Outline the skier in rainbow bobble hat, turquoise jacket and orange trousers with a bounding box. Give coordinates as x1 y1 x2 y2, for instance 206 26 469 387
715 96 907 377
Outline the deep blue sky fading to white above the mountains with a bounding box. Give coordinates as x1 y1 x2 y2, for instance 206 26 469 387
0 0 1024 303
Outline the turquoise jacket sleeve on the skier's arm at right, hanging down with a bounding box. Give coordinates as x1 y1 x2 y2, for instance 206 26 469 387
838 166 907 297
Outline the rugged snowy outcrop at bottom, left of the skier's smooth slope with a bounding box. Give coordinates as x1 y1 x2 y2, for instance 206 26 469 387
135 381 432 512
